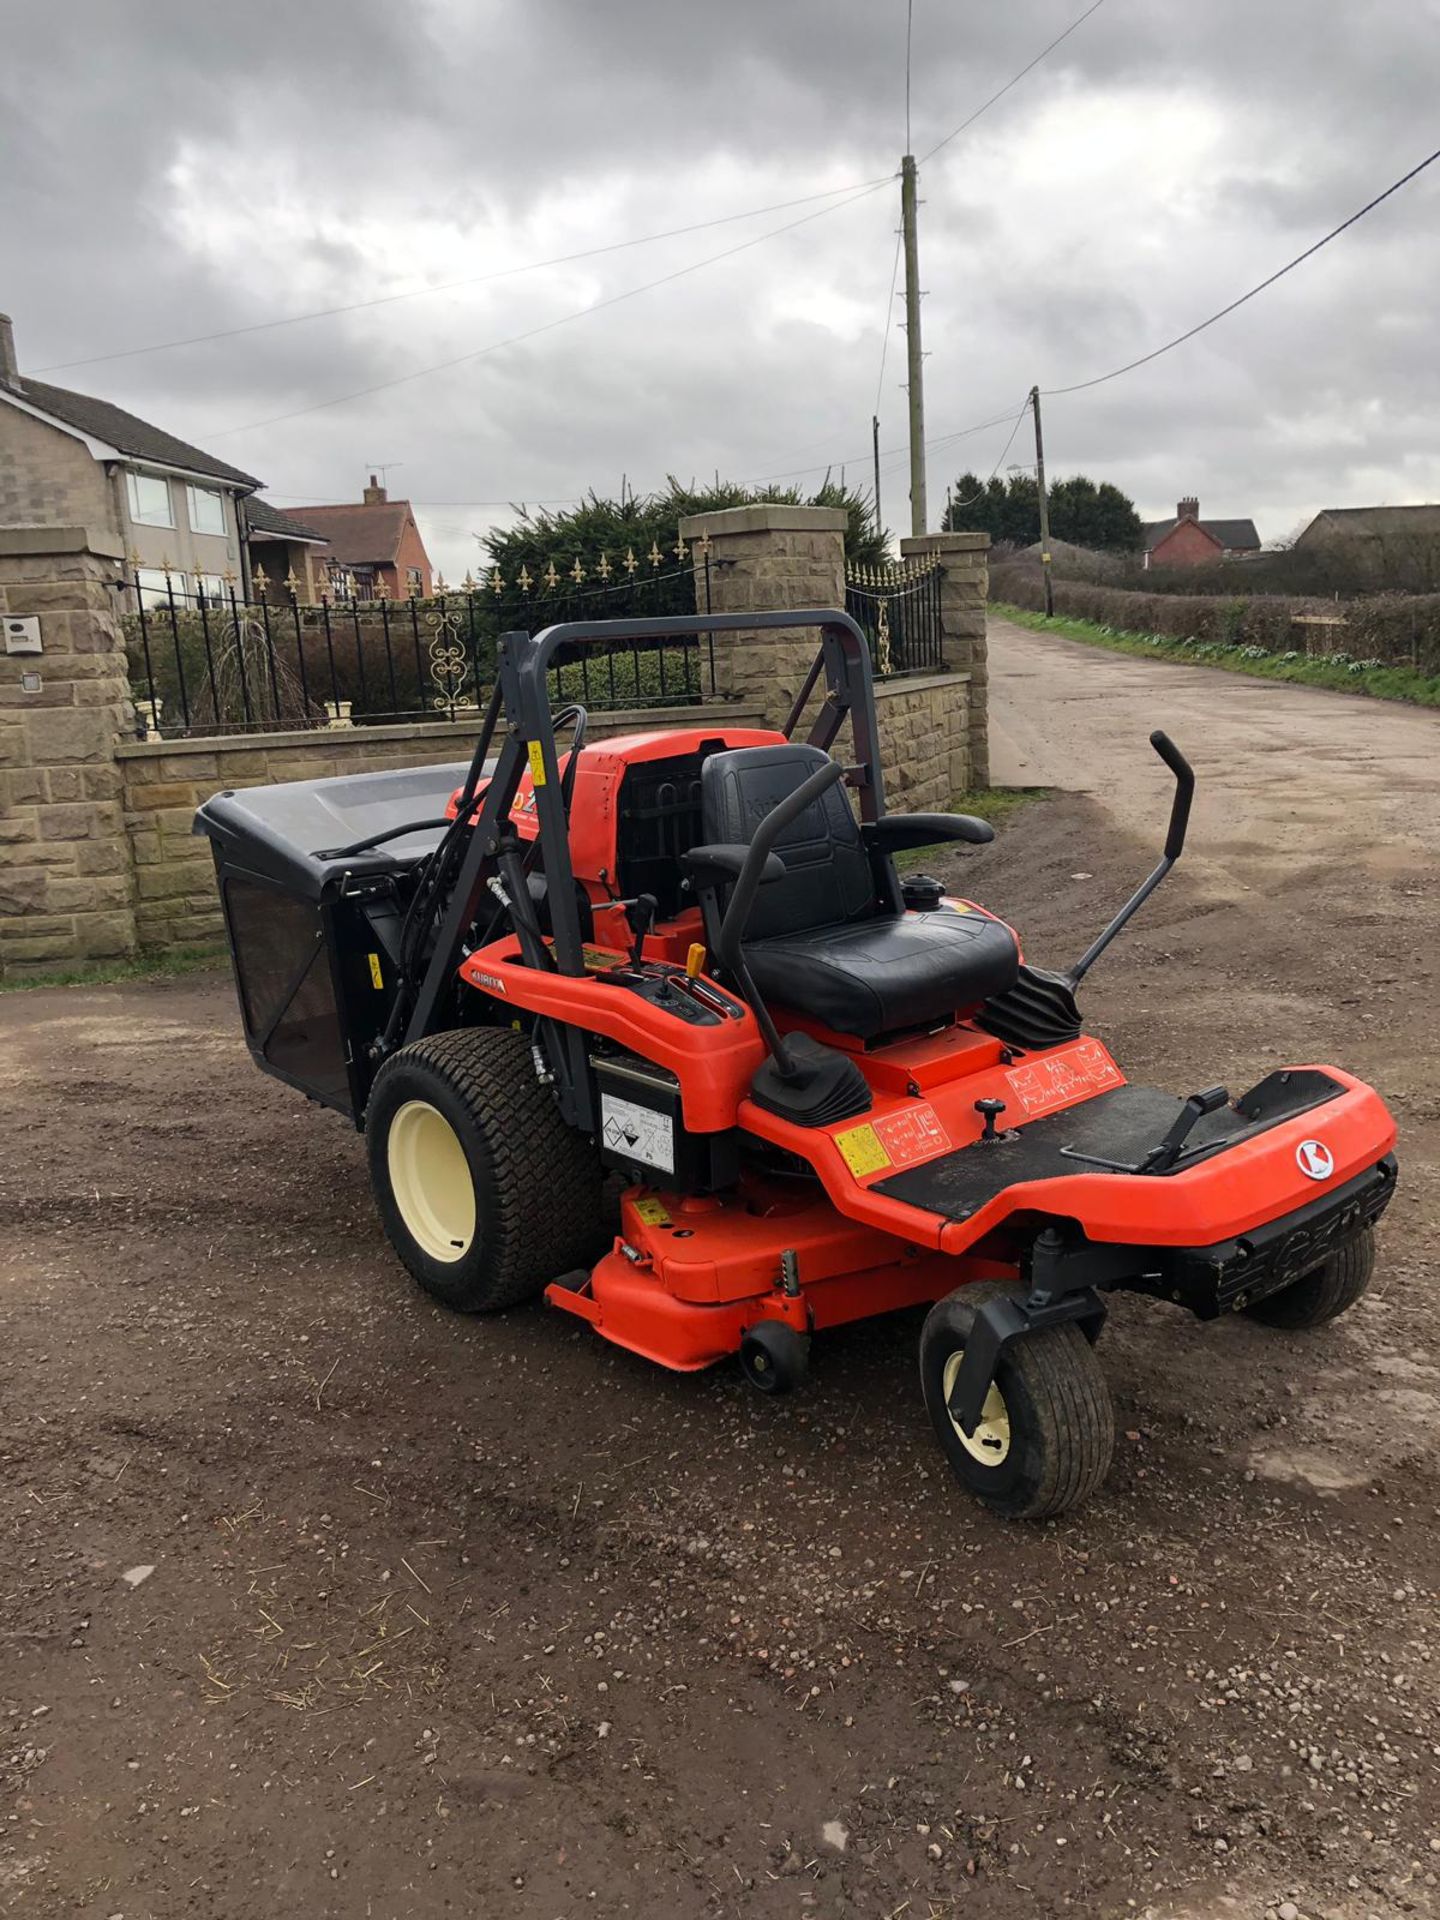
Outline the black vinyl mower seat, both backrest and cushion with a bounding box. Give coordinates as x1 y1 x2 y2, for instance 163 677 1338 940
701 743 1020 1041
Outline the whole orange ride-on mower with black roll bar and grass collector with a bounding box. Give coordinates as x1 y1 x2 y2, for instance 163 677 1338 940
196 612 1396 1517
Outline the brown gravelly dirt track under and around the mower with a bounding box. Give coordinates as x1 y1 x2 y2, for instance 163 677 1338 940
0 630 1440 1920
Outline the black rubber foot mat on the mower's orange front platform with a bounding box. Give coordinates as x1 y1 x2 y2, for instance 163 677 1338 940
872 1071 1340 1219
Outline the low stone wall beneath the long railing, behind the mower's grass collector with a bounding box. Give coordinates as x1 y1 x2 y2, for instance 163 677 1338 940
115 703 760 950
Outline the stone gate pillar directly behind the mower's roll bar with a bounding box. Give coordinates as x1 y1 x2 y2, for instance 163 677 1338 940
680 505 847 726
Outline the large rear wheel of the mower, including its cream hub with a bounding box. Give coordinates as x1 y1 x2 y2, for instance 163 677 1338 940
365 1027 603 1313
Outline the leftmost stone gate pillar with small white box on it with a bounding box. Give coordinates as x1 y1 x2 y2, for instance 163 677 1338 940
0 526 134 972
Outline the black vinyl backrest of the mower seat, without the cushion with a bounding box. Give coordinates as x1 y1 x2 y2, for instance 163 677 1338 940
701 741 877 941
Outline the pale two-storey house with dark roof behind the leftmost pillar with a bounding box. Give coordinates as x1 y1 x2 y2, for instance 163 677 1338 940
0 313 259 601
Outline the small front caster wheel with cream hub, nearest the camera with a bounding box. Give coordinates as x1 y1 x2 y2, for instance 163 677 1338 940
920 1281 1116 1521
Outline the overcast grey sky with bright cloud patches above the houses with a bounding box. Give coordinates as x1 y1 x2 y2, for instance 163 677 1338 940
0 0 1440 578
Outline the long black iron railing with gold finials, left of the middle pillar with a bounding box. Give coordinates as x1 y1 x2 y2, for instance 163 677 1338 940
123 541 720 739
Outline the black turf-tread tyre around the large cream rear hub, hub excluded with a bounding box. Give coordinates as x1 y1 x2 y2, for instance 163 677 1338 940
365 1027 607 1313
